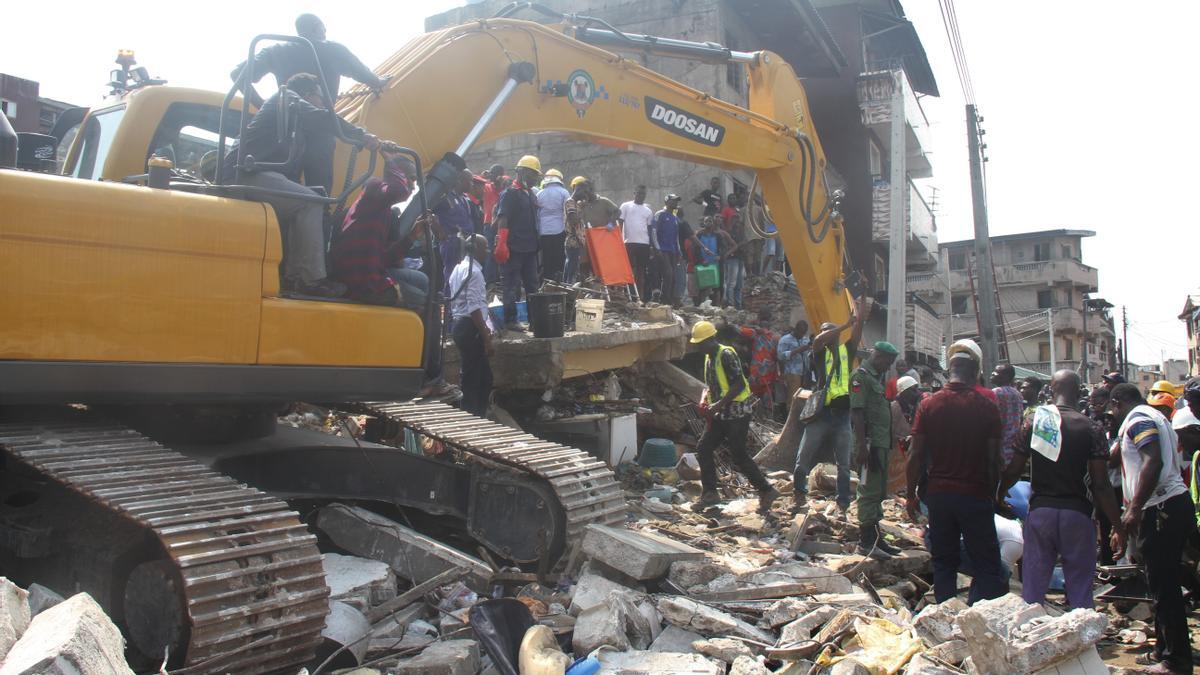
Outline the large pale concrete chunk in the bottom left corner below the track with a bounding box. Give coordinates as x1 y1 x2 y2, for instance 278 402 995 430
0 593 133 675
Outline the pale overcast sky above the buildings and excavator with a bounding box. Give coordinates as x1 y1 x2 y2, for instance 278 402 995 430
0 0 1200 364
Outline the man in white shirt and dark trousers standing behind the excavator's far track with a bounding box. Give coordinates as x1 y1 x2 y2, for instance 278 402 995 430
450 234 496 417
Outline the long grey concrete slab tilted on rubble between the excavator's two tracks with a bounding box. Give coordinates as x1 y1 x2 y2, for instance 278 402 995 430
317 503 492 592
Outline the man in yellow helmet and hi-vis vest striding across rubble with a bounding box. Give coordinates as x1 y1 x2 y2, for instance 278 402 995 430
691 321 779 513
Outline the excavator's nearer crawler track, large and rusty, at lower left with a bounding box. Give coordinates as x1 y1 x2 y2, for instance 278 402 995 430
0 418 329 674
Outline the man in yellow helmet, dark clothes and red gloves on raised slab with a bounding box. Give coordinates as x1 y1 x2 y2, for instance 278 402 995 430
496 155 541 331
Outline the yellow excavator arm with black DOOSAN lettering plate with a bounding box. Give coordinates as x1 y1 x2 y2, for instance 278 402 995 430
337 19 852 323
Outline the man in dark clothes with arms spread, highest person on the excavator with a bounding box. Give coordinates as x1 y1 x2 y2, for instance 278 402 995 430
229 14 388 196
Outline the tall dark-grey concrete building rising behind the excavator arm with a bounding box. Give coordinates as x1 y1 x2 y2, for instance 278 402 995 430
425 0 942 363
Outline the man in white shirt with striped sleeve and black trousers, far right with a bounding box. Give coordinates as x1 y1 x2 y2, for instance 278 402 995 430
1109 383 1196 673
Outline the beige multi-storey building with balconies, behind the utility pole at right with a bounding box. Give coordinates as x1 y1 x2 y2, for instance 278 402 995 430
908 229 1116 382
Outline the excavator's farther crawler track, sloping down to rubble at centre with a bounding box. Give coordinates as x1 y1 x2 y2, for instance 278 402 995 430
356 401 626 567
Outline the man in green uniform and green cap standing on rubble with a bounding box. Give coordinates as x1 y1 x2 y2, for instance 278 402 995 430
850 340 900 560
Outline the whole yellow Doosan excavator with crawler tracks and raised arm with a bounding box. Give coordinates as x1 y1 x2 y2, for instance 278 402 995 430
0 6 851 673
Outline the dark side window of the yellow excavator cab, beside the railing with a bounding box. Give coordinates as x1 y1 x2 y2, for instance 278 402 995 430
146 103 239 180
